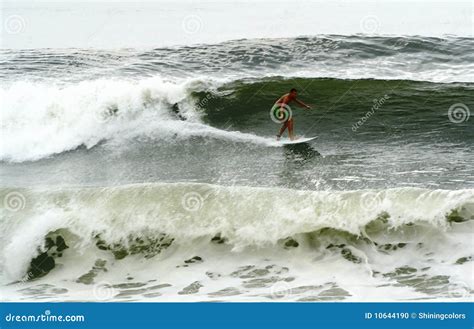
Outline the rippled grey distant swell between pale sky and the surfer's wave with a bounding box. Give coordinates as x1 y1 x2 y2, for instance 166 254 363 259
0 35 474 83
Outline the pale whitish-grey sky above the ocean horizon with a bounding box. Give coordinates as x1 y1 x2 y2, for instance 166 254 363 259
1 0 473 48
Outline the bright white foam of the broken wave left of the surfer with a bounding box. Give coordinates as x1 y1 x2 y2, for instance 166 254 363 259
0 78 231 161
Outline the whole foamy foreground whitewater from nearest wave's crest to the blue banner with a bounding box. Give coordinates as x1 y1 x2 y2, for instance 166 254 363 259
1 183 474 301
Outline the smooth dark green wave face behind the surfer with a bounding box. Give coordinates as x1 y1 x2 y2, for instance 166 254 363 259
194 77 474 144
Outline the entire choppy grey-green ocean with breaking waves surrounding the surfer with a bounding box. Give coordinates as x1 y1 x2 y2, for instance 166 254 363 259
0 1 474 302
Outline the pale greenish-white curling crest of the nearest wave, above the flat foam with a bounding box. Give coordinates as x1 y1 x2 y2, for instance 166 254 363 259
1 183 474 277
